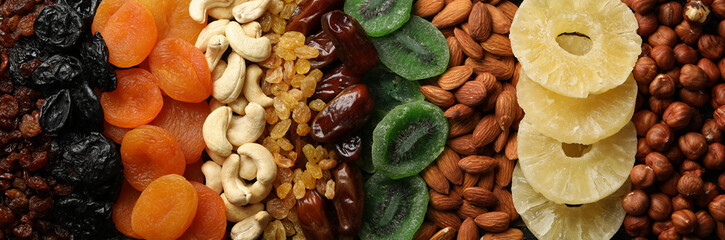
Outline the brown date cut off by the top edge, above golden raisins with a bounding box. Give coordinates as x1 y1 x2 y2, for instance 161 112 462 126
287 0 345 36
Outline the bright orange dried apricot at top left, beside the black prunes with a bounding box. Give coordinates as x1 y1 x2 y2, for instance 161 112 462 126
91 0 157 68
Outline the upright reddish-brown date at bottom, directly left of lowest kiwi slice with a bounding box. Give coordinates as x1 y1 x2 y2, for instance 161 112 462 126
332 163 365 237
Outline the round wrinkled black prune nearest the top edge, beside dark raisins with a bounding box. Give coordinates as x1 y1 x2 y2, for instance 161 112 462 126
33 4 83 48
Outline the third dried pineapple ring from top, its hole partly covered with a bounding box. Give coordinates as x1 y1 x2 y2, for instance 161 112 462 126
518 118 637 204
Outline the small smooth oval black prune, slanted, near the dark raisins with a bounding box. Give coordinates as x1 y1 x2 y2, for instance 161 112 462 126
40 89 71 133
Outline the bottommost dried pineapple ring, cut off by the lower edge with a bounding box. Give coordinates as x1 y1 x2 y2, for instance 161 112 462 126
511 166 630 240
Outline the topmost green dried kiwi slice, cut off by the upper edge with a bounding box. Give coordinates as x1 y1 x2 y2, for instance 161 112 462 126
345 0 413 37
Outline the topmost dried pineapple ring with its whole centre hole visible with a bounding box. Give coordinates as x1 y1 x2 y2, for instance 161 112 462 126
509 0 642 98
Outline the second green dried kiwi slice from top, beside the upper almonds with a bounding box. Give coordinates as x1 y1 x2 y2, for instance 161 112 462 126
372 16 450 80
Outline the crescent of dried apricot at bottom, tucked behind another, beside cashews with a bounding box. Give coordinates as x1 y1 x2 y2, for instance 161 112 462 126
179 181 227 240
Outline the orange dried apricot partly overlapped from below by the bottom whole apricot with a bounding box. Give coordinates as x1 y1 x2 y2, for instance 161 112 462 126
121 125 186 191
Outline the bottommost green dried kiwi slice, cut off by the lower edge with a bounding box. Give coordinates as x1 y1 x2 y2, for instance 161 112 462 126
360 173 429 240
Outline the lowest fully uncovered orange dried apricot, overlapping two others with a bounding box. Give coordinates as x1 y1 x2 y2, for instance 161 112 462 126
131 174 199 240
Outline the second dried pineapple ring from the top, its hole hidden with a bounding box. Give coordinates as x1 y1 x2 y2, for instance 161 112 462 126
516 71 637 144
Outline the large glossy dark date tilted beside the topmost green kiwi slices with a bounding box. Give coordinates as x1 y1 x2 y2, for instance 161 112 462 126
322 10 378 74
